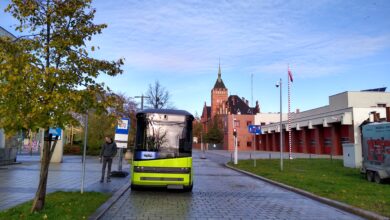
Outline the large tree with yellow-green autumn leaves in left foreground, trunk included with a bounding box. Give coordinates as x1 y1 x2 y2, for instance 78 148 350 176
0 0 123 212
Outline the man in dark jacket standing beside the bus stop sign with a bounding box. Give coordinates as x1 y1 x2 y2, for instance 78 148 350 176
100 136 117 183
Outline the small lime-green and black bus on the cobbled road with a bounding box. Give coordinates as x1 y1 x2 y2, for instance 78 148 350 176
131 109 194 191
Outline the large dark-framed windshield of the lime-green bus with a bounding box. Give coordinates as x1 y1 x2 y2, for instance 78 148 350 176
134 113 192 160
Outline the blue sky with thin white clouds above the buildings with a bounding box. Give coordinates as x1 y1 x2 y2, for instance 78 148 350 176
0 0 390 115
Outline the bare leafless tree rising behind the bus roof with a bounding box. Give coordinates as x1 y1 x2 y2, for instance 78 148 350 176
146 80 170 109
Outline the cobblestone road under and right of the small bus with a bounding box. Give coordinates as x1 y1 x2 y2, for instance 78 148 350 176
102 151 359 220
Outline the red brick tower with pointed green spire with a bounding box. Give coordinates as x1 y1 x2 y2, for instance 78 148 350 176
211 64 228 118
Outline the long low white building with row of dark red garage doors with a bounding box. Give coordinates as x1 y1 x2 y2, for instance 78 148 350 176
257 91 390 167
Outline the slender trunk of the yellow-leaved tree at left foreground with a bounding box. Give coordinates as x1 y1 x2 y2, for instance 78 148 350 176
31 129 57 213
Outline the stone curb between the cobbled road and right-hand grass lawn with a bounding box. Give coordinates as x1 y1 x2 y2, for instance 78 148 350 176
225 163 390 220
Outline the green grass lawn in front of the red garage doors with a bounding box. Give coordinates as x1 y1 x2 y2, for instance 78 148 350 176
229 159 390 217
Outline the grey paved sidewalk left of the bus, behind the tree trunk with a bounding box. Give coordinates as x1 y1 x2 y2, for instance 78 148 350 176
0 155 130 210
